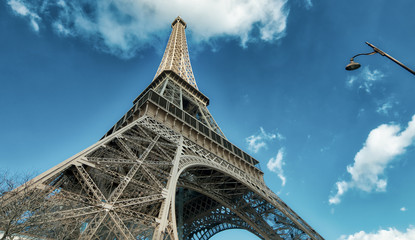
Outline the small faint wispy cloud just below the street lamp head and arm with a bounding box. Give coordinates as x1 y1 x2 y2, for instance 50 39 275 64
346 66 385 93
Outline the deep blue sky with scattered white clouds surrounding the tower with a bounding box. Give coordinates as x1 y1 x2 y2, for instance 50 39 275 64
0 0 415 240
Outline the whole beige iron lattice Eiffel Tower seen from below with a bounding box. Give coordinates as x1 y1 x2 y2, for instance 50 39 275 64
5 17 323 240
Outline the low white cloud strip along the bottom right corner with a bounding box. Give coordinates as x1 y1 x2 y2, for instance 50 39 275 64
339 226 415 240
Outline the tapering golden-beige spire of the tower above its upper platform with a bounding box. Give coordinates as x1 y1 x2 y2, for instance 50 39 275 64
154 17 198 89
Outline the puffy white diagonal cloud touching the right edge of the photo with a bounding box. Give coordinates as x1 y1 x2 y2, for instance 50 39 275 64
329 115 415 204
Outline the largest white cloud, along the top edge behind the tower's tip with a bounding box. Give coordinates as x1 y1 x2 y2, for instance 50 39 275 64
8 0 289 58
